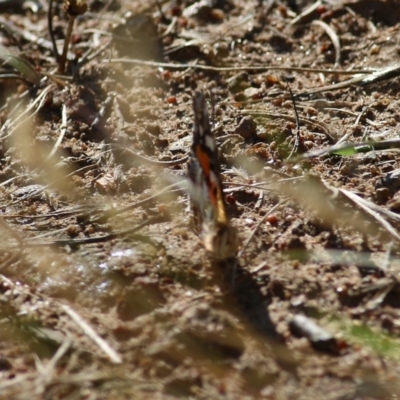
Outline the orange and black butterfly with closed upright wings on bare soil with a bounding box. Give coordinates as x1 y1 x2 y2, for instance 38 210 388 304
188 91 238 260
